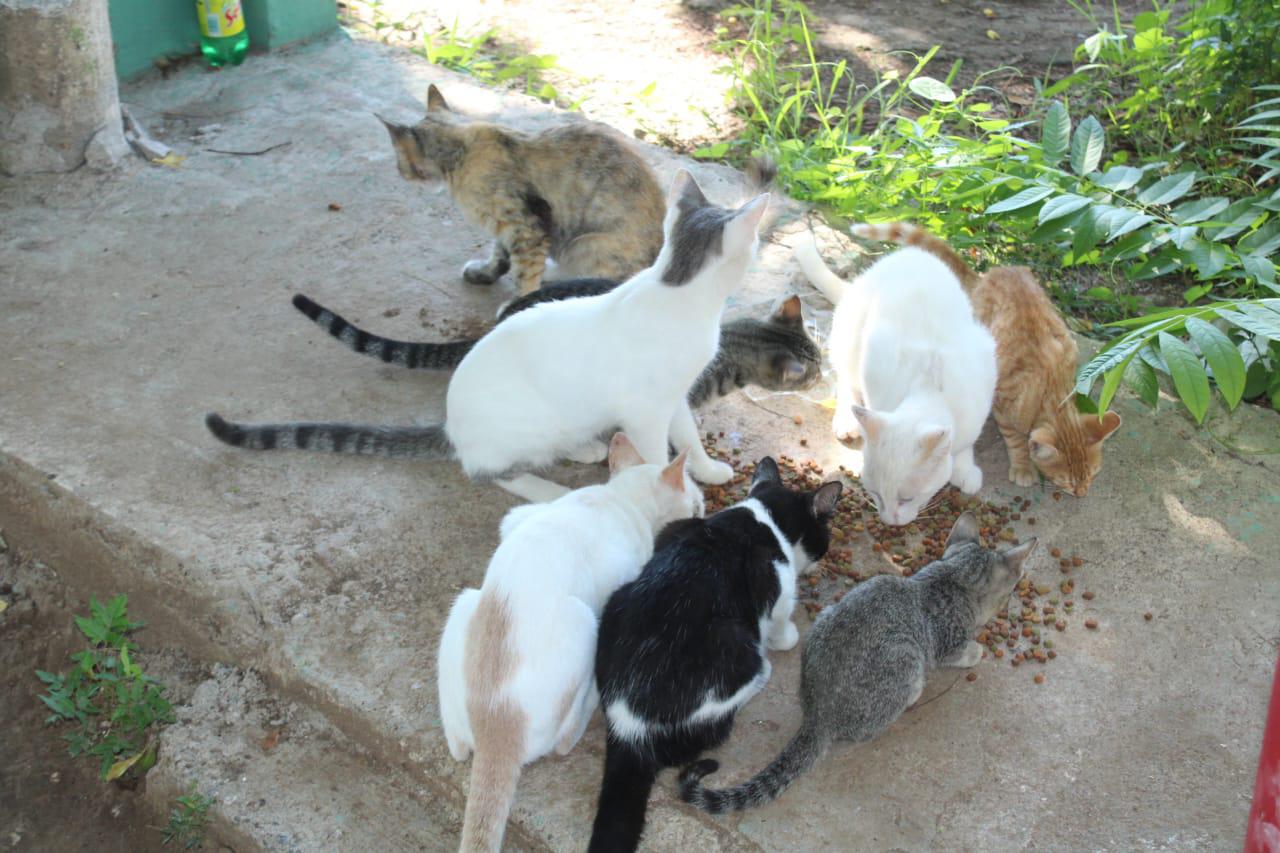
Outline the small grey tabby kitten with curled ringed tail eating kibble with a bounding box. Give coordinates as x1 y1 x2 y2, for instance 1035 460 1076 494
680 512 1036 813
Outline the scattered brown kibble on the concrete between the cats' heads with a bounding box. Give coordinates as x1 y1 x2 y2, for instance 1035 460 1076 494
704 433 1098 684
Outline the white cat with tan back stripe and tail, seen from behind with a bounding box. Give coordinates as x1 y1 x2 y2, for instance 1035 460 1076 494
438 433 703 852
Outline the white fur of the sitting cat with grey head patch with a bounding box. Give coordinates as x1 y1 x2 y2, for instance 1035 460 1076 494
445 170 769 501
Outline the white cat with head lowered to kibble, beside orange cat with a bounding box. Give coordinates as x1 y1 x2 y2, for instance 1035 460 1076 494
796 238 996 525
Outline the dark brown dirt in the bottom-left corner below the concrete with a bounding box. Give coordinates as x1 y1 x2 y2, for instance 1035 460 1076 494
0 553 169 853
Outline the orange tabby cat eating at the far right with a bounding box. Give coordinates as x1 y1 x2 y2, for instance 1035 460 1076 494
854 223 1120 497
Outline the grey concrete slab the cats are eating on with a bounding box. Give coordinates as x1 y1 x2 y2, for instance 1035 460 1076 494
0 29 1280 850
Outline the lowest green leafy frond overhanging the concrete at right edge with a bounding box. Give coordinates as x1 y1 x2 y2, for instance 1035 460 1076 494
1075 297 1280 423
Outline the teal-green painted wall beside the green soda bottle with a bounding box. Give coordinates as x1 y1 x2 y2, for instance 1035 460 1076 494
108 0 338 79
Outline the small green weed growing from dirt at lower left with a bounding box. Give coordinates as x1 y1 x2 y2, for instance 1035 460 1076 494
36 596 174 781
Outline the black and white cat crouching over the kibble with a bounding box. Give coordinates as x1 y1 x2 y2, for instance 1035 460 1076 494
590 457 841 853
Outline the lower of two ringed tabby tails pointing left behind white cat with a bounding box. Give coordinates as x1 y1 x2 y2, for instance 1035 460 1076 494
205 412 453 459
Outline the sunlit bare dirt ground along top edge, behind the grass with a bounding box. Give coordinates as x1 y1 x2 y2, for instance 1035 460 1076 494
343 0 1149 152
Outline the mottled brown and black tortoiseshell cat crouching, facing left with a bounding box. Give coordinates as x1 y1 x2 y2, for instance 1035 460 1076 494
381 86 667 293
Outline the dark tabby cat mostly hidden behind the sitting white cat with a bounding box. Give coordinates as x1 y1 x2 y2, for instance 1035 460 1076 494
293 285 822 409
